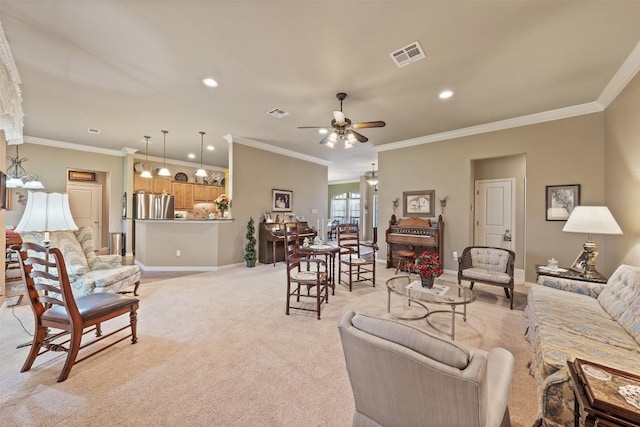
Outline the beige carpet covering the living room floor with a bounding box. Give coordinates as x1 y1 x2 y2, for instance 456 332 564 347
0 263 536 426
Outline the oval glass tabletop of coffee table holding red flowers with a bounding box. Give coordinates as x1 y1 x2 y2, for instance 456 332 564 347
387 275 476 306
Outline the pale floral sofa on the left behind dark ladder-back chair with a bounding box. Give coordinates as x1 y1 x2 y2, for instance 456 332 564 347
20 227 140 298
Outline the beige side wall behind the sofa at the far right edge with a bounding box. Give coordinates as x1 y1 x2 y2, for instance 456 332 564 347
596 70 640 271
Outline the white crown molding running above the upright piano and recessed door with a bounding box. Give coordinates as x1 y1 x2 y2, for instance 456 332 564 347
373 102 604 152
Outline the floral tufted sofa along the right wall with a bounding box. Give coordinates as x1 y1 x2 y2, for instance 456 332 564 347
525 265 640 426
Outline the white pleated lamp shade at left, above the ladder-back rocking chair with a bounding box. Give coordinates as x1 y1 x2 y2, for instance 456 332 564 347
15 191 78 233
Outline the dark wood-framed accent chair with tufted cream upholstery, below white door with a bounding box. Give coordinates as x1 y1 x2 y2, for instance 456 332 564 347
458 246 516 310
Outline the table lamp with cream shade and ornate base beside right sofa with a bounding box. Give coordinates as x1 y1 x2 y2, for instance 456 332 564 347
562 206 622 279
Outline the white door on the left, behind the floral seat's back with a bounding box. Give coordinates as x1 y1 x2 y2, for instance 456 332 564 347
67 184 102 250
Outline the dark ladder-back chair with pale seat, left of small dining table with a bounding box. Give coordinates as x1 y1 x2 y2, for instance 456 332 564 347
284 223 329 320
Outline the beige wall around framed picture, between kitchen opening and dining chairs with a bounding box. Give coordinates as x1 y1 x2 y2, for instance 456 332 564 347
225 143 328 265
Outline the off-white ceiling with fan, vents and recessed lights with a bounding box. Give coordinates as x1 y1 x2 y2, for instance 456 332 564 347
0 0 640 182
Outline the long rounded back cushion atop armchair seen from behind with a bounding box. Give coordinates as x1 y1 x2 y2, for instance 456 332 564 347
351 313 471 369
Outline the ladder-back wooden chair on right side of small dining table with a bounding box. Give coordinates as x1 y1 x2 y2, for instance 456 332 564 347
338 224 378 292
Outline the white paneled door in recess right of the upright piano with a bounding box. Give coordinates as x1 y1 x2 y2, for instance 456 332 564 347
474 178 515 250
